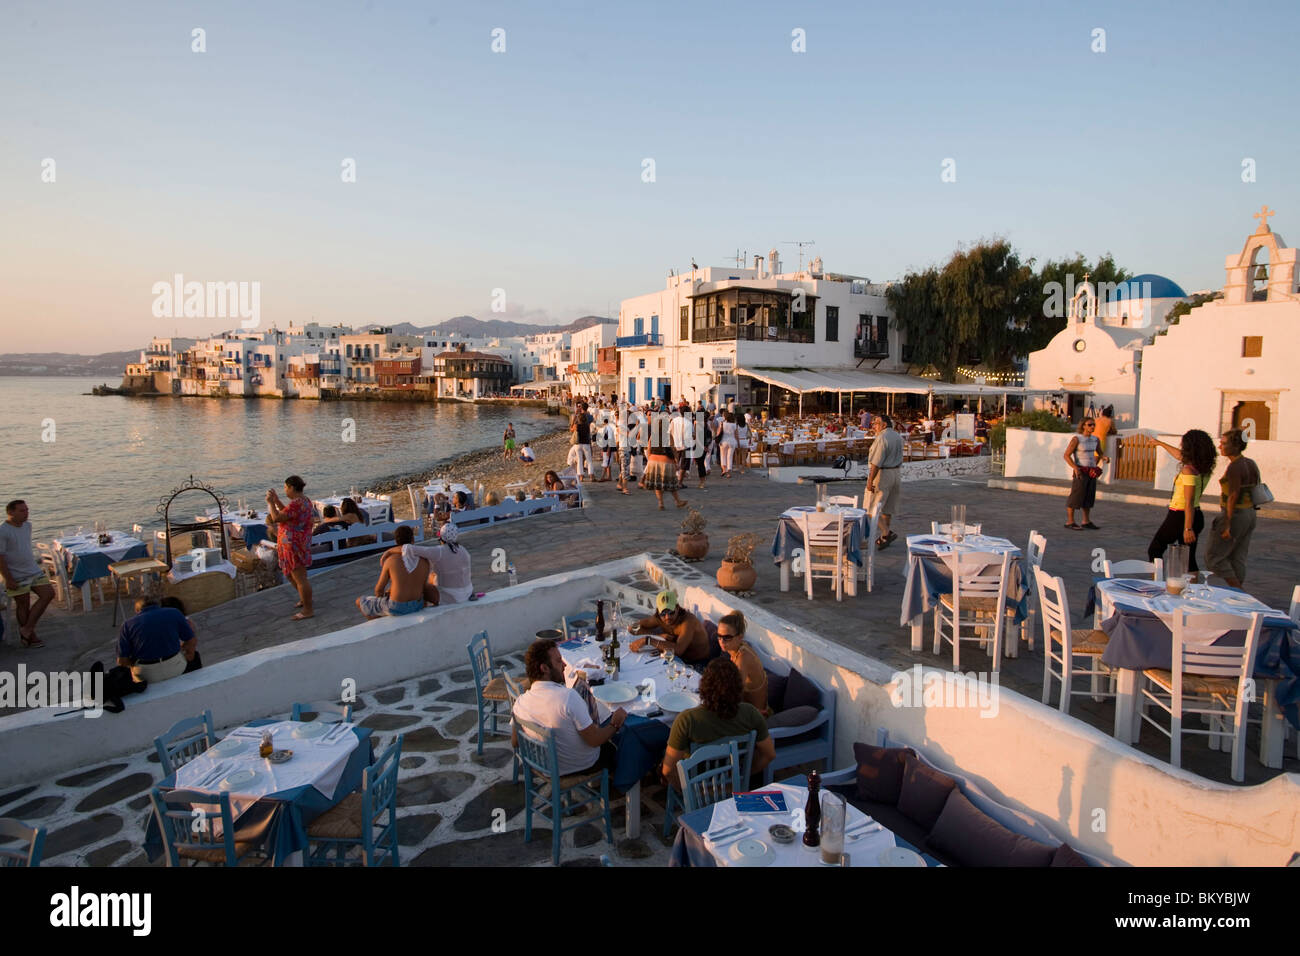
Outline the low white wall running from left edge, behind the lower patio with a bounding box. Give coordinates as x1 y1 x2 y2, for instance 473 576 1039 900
0 558 644 790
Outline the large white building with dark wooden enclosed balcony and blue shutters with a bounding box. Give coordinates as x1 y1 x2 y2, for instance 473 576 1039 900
616 250 905 405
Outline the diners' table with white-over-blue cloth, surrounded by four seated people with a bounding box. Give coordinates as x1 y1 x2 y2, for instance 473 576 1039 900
559 628 699 839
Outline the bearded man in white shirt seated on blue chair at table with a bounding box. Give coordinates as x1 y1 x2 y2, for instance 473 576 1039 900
511 641 628 775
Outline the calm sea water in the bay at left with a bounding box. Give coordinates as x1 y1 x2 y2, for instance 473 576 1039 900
0 377 562 540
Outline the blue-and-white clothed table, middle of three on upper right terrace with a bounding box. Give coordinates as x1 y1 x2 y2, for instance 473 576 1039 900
898 535 1030 657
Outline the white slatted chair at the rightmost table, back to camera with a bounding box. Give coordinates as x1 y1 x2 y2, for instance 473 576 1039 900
1141 607 1264 783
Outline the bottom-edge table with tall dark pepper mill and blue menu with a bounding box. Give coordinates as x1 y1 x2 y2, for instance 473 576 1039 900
670 778 939 866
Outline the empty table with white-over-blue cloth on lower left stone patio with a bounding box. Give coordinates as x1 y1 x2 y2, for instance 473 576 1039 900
144 719 374 866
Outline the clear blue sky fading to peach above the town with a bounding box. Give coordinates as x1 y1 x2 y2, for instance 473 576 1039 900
0 0 1300 352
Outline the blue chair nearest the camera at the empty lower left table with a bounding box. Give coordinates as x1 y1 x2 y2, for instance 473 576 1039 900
150 787 281 866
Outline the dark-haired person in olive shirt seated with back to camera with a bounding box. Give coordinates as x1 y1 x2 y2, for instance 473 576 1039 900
659 657 776 790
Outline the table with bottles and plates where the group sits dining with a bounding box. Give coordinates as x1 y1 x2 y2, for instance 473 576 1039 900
559 632 699 839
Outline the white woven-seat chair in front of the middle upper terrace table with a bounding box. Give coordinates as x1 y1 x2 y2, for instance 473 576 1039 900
935 551 1011 671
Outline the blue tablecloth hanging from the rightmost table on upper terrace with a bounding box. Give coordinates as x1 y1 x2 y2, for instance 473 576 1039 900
1101 580 1300 727
